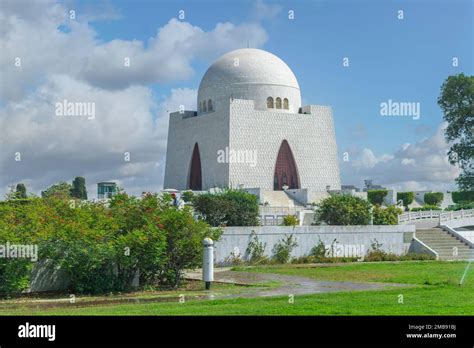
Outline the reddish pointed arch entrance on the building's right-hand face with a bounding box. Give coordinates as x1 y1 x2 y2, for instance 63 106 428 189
273 140 300 191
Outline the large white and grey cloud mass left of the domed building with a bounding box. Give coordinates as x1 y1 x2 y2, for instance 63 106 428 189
0 1 267 197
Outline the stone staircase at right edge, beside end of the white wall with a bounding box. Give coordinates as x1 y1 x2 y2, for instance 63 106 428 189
415 228 474 260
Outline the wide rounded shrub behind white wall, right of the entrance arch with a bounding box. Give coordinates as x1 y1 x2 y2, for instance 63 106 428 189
315 195 371 225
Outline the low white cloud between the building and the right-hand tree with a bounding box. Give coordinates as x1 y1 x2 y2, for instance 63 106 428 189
341 124 459 190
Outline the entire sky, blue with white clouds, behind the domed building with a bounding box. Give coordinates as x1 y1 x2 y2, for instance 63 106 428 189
0 0 474 193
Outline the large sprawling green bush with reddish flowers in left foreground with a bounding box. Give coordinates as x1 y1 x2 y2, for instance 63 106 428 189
0 192 221 293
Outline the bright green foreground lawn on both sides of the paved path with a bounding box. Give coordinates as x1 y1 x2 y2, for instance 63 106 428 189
0 261 474 315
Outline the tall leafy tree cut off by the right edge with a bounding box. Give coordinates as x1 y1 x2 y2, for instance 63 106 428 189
438 74 474 191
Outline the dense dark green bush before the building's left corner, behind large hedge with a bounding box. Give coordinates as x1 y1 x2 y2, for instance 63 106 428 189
193 189 259 226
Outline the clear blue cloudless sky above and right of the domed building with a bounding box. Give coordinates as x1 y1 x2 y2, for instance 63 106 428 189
86 0 474 153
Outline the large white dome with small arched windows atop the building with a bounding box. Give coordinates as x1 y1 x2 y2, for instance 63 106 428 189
198 48 301 113
